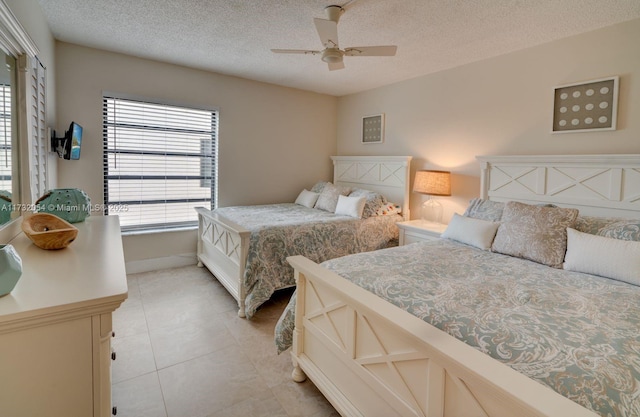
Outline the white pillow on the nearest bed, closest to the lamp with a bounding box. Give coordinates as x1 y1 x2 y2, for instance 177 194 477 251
440 213 500 250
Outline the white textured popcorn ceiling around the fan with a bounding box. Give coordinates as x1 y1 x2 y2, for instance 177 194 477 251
39 0 640 96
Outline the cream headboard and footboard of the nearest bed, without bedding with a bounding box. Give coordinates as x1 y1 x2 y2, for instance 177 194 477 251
289 155 640 417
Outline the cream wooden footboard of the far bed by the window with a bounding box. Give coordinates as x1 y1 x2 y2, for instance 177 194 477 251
196 207 251 317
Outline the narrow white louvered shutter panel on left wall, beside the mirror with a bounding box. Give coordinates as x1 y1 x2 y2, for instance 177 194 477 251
29 58 49 201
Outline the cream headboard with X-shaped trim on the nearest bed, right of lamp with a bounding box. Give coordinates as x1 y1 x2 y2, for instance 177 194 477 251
478 155 640 217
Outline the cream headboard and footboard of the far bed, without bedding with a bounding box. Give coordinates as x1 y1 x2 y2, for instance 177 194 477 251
196 156 411 317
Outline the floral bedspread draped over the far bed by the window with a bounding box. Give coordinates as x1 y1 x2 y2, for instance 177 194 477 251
215 203 402 318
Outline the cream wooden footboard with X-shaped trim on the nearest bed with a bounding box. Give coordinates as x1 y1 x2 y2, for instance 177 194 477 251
288 256 595 417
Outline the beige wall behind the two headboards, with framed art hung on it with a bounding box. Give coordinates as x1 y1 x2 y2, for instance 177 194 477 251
338 20 640 221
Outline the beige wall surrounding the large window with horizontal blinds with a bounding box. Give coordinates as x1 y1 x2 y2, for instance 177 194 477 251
56 42 337 262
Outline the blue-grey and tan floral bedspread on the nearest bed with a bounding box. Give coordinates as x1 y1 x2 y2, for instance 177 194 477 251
276 239 640 416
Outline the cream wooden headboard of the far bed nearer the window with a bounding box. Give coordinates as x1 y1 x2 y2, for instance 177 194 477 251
331 156 412 220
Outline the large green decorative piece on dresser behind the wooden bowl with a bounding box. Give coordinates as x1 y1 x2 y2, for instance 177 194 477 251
36 188 91 223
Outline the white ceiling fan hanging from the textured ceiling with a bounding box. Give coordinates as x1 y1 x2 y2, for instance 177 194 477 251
271 6 398 71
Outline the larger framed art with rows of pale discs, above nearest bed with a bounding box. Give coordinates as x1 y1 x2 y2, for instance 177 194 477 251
552 76 618 133
